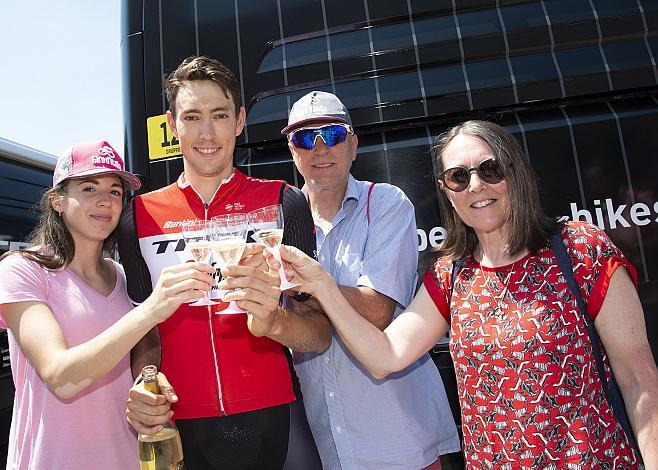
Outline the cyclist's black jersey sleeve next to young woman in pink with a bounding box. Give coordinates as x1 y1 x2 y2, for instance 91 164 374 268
117 200 153 304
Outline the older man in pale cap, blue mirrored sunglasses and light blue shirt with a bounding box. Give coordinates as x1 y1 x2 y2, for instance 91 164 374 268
243 91 459 469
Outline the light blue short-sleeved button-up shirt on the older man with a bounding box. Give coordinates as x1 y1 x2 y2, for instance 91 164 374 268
294 175 459 470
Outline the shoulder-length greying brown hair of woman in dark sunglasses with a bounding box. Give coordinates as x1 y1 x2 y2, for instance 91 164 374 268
432 121 557 260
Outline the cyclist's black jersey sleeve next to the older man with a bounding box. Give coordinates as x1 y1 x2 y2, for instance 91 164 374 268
281 185 316 259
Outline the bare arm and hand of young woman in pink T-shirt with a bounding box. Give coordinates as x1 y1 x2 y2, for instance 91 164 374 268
2 264 212 399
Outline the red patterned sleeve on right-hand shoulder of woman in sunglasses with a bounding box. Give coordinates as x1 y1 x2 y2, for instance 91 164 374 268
562 222 637 319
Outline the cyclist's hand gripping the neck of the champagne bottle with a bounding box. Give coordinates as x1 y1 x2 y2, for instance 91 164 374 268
126 372 178 434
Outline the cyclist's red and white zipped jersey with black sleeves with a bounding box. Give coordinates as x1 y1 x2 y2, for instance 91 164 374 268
119 170 315 419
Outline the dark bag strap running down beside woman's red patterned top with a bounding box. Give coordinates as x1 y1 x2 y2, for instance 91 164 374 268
550 230 641 458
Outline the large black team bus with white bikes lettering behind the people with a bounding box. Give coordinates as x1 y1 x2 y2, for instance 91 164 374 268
121 0 658 466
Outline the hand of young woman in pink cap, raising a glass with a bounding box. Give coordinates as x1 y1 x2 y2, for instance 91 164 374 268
144 263 215 323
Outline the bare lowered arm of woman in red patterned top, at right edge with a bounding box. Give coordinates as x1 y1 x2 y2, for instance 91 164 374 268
595 269 658 469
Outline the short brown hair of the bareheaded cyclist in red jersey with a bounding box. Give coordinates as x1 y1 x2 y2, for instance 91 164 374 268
164 56 241 116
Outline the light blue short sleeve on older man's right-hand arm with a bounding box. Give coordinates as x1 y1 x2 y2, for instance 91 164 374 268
356 183 418 308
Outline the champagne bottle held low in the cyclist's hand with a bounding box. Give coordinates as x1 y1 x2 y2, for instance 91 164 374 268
137 366 185 470
